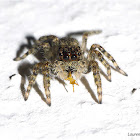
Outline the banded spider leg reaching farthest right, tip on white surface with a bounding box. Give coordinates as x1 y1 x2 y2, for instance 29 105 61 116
91 44 128 76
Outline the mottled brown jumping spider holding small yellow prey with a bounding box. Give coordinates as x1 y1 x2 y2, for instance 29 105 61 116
14 30 127 105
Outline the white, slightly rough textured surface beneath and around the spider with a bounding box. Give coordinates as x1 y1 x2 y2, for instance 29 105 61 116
0 0 140 140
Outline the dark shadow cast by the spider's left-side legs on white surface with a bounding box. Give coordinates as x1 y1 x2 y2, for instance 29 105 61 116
16 35 67 103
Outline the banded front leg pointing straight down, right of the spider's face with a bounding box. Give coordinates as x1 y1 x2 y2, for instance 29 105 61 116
91 61 102 104
